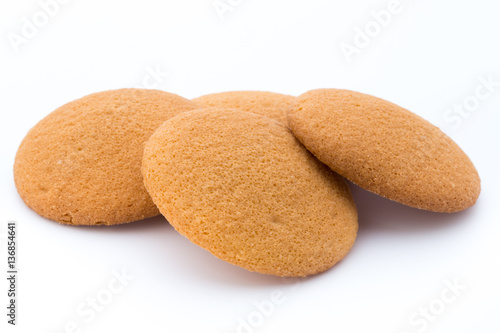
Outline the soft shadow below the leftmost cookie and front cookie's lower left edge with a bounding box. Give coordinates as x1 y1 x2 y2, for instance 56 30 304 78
51 216 293 287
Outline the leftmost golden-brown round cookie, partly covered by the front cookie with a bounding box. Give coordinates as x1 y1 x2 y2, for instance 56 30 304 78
14 89 197 225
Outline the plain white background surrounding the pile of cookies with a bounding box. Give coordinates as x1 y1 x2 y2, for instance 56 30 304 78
0 0 500 333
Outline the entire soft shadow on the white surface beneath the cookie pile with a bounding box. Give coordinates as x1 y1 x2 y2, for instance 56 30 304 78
27 179 471 288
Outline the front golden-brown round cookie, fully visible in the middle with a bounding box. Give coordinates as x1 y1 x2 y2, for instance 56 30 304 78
142 108 358 276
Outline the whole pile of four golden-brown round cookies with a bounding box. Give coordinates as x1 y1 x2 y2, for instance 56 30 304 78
14 89 480 276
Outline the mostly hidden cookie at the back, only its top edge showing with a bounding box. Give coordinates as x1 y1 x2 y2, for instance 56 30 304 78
193 91 296 124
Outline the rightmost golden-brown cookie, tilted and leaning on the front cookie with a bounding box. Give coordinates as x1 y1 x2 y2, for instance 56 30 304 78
288 89 481 212
